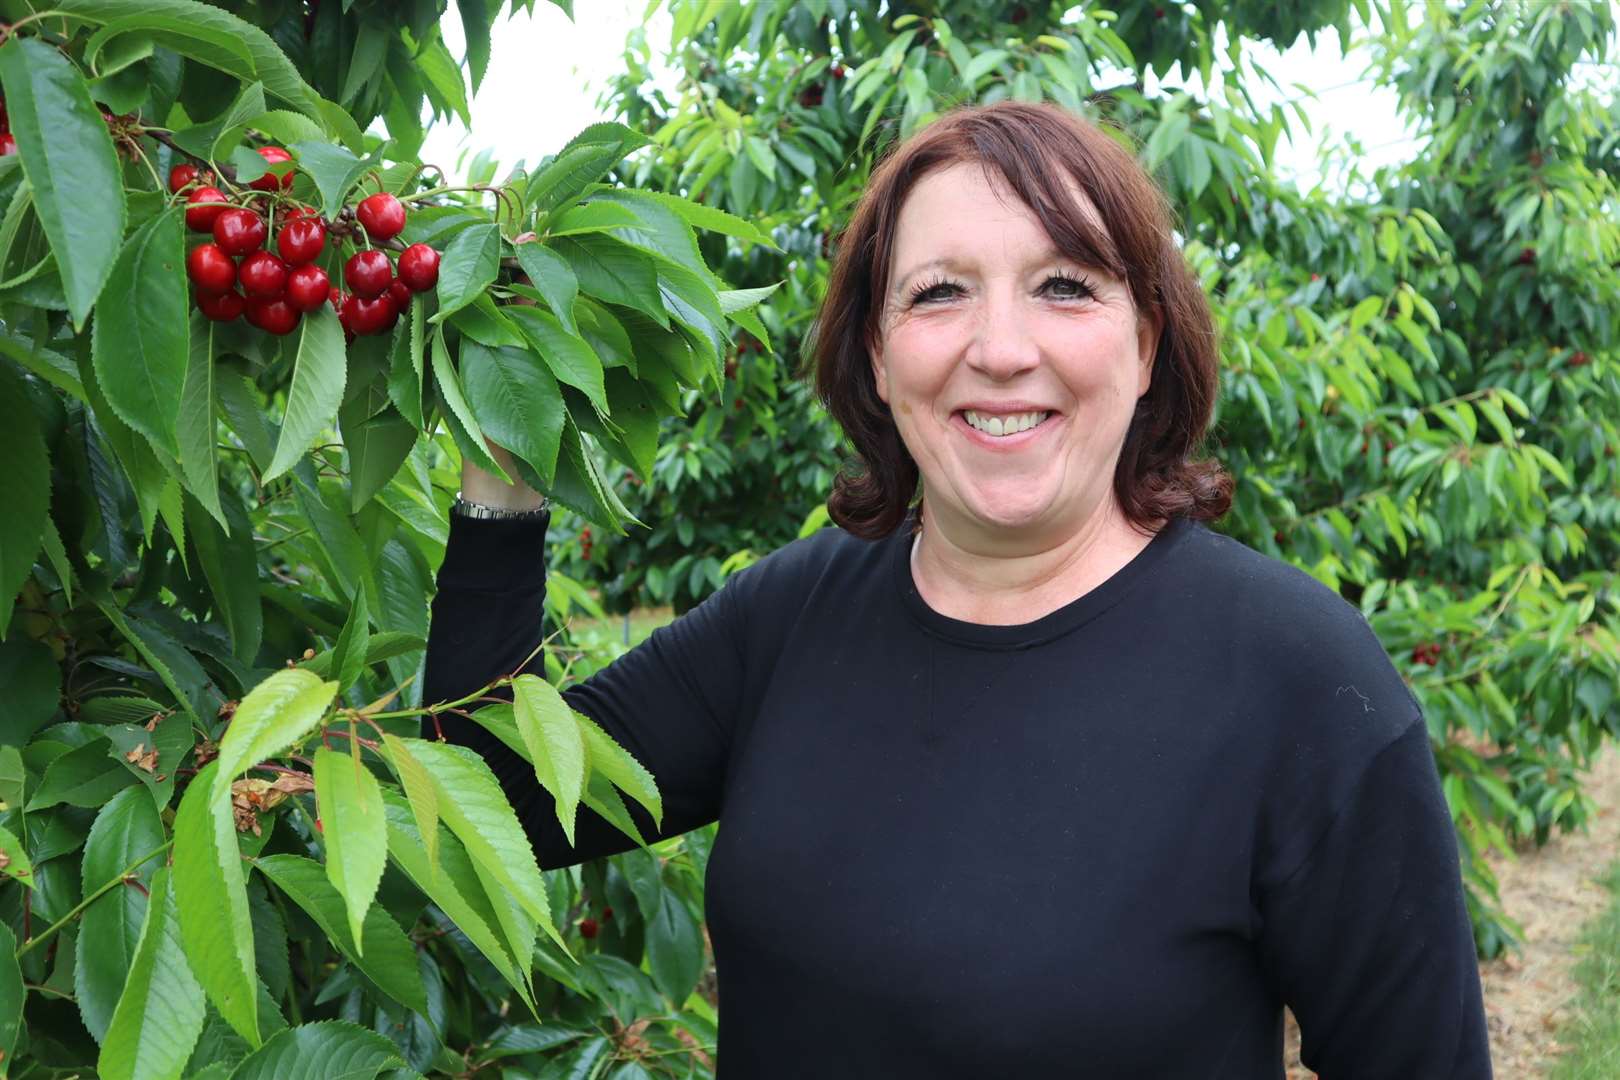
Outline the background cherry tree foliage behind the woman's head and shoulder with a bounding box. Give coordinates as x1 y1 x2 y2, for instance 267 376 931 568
569 0 1620 954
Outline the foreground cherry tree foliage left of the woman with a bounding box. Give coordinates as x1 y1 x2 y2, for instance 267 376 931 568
0 0 763 1078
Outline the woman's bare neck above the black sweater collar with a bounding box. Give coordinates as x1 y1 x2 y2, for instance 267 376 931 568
910 499 1157 627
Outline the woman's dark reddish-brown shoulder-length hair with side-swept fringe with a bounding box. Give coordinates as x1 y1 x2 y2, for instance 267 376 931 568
812 102 1231 539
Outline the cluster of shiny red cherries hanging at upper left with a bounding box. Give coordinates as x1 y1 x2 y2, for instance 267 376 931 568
168 146 439 337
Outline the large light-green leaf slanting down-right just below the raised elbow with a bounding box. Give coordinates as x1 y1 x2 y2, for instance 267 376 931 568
402 738 565 947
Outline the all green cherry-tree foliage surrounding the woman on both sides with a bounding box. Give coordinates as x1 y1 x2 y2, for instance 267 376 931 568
0 0 1620 1080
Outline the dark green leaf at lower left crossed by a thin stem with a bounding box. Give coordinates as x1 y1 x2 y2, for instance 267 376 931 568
73 787 164 1043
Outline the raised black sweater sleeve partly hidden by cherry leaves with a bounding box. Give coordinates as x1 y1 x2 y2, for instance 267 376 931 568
421 515 742 870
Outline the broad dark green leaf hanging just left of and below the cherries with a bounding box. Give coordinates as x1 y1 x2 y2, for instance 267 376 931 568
91 210 191 460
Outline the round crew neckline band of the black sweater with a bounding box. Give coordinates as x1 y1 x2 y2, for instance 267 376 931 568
888 518 1192 649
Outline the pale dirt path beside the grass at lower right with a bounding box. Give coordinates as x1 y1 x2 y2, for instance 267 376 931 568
1285 748 1620 1080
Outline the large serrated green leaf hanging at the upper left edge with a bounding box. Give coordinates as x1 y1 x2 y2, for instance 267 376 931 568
0 37 125 325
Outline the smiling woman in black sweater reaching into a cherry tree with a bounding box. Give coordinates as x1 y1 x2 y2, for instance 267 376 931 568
424 104 1490 1080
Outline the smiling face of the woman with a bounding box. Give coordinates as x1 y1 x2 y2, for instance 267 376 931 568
873 165 1157 546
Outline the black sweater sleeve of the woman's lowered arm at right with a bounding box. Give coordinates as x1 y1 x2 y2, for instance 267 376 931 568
1259 717 1490 1080
